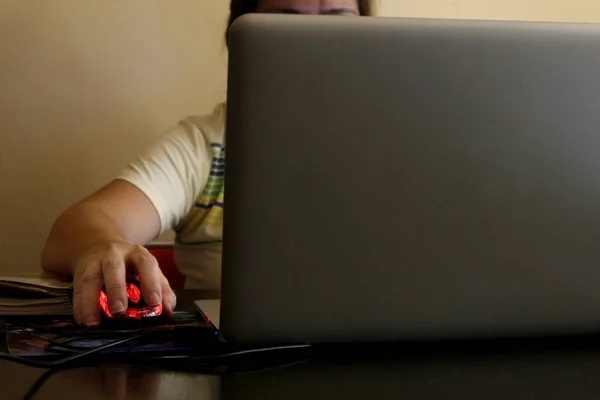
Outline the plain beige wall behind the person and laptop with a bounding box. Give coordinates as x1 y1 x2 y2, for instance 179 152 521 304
0 0 600 272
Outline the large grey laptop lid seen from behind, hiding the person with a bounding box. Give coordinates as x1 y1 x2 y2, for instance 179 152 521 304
212 15 600 344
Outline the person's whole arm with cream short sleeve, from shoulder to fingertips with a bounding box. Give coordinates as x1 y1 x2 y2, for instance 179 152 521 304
42 112 224 325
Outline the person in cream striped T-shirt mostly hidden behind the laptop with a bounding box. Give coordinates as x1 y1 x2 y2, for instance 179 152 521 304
42 0 372 326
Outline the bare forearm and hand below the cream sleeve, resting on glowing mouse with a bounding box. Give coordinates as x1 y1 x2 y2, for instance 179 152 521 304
42 180 175 325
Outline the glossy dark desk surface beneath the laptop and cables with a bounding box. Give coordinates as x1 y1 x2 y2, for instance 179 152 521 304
0 293 600 400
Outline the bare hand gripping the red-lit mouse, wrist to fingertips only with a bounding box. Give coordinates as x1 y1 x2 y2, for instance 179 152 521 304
73 242 176 326
